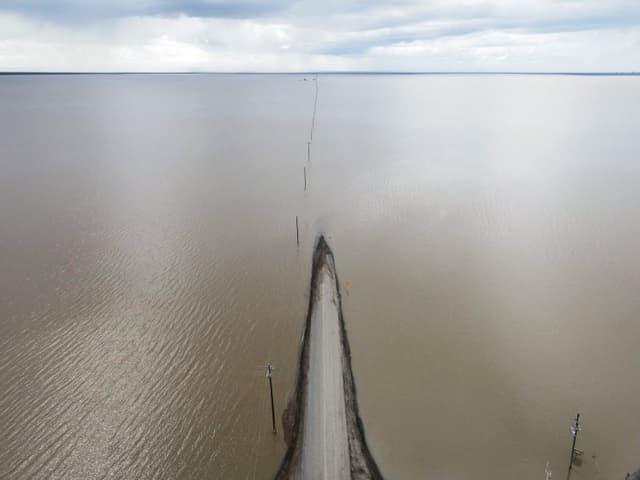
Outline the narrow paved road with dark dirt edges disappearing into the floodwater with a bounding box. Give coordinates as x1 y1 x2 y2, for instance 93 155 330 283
276 237 382 480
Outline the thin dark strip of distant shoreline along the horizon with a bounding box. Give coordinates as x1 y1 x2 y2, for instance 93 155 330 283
0 71 640 77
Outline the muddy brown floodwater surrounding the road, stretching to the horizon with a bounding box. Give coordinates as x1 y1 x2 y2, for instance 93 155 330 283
0 76 640 480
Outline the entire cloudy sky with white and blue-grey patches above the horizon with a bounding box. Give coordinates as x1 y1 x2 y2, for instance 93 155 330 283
0 0 640 72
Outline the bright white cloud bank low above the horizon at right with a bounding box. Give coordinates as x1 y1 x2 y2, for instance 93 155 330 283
369 30 640 72
